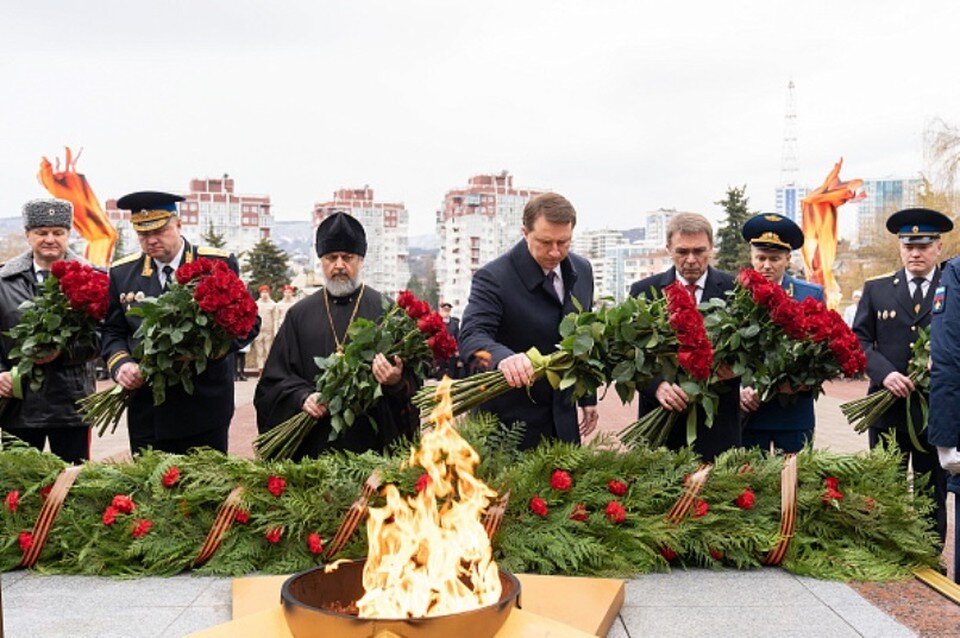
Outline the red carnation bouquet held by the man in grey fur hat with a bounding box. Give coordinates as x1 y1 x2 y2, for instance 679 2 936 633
0 261 109 418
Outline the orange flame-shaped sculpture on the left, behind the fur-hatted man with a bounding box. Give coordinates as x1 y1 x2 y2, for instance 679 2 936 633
37 147 117 266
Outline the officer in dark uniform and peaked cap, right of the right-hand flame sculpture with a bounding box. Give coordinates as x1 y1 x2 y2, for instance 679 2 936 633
853 208 953 540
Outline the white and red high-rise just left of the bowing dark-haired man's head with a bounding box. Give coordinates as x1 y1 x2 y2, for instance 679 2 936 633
436 171 544 313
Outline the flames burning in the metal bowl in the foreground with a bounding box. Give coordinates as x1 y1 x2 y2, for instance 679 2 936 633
357 379 501 618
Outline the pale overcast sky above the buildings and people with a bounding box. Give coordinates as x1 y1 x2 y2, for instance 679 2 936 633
0 0 960 234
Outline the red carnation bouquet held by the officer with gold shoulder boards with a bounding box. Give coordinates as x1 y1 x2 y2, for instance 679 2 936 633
78 258 257 436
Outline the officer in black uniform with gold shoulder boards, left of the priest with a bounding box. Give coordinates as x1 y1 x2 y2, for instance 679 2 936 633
103 191 259 453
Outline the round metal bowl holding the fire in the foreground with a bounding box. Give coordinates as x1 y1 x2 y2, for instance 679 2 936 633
280 560 520 638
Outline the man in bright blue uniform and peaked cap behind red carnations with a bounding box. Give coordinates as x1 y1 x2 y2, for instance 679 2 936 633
740 214 823 452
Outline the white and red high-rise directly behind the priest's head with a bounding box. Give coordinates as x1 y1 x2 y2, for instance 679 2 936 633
313 186 410 296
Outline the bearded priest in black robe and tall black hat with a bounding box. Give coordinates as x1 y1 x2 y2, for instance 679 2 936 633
253 213 420 460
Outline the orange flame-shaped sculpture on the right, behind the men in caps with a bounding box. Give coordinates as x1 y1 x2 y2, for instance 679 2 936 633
802 157 865 308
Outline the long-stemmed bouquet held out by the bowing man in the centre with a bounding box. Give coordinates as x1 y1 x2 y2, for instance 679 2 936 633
414 286 713 417
